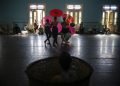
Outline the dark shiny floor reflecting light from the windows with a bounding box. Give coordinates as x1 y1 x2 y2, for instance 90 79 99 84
0 34 120 86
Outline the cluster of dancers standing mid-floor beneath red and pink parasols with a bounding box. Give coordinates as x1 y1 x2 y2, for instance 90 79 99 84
44 17 75 47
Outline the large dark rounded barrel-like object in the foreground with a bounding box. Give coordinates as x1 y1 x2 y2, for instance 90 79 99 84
26 57 93 86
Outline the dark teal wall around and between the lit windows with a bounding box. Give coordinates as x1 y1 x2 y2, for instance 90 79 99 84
0 0 120 30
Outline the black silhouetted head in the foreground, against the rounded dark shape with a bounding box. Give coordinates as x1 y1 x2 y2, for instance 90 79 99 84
59 52 72 71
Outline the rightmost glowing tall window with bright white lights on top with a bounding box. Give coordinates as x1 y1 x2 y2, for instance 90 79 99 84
102 5 118 31
